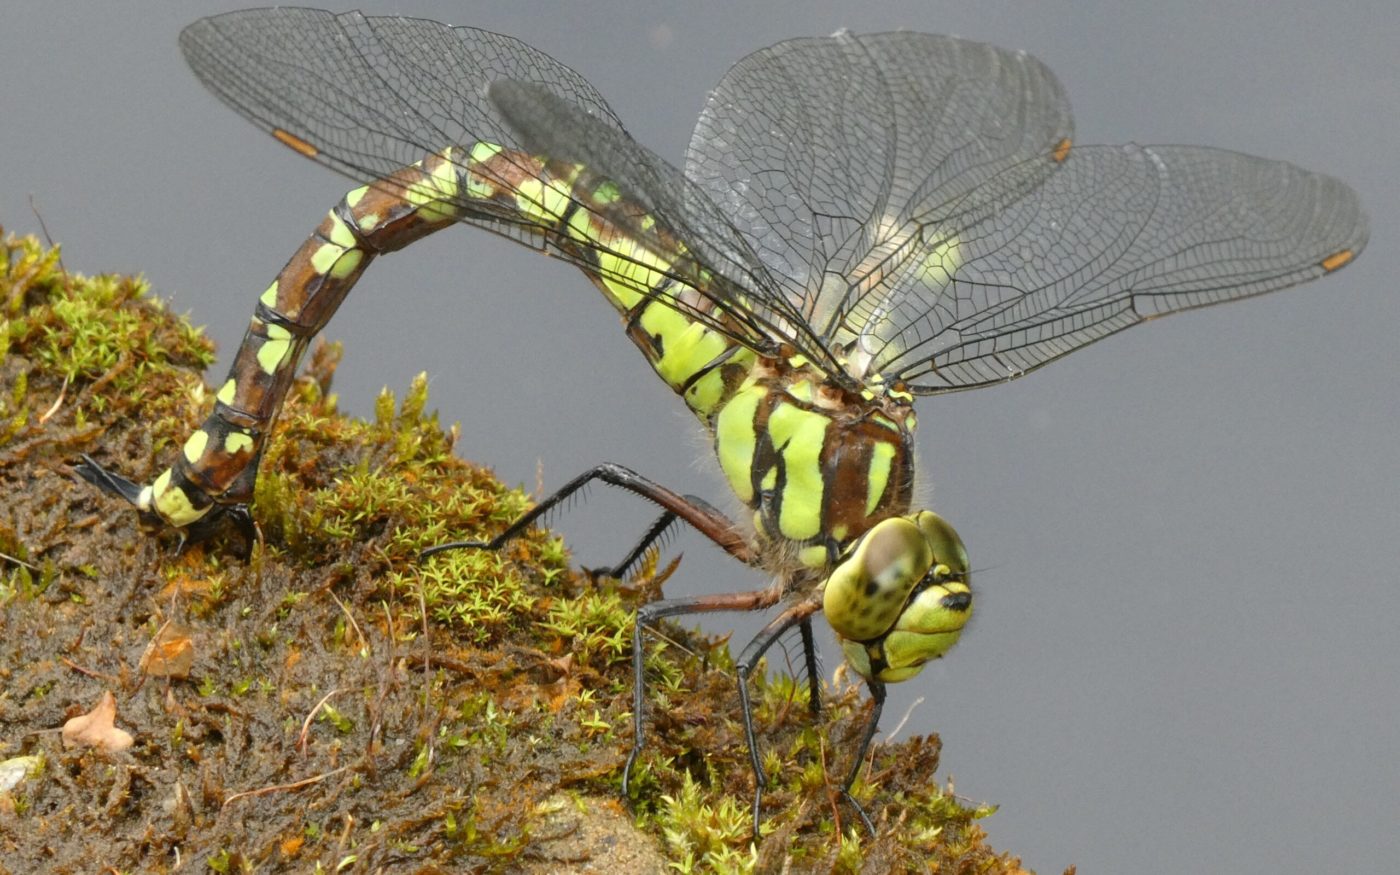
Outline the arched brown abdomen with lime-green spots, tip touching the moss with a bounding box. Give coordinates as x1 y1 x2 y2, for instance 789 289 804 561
139 143 753 528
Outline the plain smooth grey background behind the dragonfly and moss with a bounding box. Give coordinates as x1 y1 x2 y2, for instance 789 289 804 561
0 0 1400 872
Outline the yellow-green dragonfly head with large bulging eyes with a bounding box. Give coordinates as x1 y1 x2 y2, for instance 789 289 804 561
822 511 972 683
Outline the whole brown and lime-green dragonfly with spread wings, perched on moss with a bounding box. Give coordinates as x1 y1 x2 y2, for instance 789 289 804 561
78 8 1368 836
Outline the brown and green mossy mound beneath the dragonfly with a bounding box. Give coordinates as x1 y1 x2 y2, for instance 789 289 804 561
0 232 1036 872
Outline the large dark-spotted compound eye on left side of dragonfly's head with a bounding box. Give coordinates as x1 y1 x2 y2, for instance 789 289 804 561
822 517 934 641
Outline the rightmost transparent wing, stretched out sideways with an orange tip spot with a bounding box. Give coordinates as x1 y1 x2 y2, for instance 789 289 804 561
848 146 1368 393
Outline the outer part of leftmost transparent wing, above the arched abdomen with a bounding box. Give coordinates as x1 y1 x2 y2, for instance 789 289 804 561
179 8 622 181
